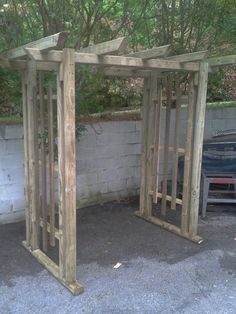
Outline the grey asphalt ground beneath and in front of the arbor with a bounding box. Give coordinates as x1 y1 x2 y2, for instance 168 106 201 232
0 203 236 314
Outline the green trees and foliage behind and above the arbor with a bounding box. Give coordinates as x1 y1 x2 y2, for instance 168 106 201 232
0 0 236 115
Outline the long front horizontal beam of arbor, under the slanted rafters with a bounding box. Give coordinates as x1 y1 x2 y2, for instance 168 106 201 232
24 48 199 71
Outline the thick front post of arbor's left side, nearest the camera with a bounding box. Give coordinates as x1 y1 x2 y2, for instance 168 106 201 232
57 48 76 282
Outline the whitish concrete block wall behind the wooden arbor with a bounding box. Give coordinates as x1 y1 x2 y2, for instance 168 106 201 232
0 108 236 223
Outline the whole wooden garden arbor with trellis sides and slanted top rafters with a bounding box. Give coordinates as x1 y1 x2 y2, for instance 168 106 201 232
0 32 235 294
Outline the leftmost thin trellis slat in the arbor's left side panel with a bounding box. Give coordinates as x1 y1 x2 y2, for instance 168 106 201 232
38 72 48 252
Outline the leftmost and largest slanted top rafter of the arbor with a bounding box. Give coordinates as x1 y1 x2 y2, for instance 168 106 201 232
0 32 67 59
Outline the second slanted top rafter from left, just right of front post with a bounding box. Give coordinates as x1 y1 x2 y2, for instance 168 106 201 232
78 37 128 55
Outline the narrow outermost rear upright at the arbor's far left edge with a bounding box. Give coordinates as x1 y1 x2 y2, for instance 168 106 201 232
21 72 31 246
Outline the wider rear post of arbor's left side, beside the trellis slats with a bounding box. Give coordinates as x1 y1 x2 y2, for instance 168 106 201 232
27 61 39 250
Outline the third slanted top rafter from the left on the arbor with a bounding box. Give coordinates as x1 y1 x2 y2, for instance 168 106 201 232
125 45 171 60
